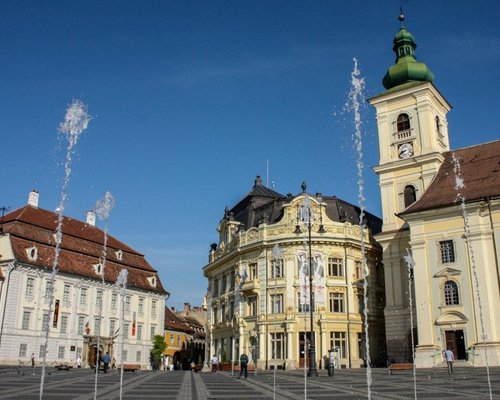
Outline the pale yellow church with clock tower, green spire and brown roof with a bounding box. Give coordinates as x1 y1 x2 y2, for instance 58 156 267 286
370 17 500 367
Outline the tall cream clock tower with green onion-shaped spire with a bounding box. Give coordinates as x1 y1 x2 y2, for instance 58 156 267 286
369 15 451 361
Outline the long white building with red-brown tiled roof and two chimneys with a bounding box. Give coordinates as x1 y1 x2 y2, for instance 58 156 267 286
0 191 168 368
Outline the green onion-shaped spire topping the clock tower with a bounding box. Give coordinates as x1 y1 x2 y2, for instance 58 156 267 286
382 10 434 89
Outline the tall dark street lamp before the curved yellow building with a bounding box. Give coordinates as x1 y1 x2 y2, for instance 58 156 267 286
295 182 326 377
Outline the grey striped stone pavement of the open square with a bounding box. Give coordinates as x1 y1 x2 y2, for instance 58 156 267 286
0 367 500 400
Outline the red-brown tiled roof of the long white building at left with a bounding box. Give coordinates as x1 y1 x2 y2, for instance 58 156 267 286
3 205 167 294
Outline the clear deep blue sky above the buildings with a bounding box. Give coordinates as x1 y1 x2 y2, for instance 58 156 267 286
0 0 500 307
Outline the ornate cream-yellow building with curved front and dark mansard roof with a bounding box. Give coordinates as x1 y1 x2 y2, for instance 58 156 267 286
203 177 385 369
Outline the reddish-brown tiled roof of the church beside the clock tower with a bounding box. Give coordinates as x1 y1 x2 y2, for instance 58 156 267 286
399 140 500 217
